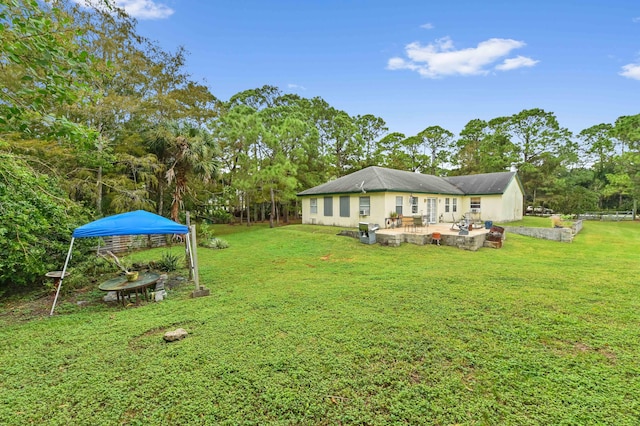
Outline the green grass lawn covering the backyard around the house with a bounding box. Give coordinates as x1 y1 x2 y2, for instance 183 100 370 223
0 218 640 425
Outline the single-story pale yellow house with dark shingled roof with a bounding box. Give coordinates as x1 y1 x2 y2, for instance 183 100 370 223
298 166 524 228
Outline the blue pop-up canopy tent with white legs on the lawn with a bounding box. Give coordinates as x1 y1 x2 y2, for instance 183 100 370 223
49 210 194 315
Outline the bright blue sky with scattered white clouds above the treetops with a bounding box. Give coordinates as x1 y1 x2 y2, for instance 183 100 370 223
92 0 640 136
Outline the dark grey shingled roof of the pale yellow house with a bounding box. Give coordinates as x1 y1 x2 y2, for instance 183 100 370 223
298 166 515 196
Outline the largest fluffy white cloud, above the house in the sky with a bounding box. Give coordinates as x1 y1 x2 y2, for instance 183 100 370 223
387 37 538 78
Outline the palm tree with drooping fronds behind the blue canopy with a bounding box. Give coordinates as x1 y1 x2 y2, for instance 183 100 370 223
148 121 218 221
